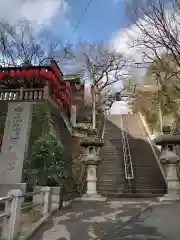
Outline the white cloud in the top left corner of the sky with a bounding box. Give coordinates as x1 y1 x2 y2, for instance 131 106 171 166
0 0 69 28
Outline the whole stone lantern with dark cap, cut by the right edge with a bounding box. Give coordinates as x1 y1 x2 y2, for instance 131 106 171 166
155 134 180 200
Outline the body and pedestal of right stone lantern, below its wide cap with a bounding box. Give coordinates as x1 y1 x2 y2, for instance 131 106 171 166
160 149 180 201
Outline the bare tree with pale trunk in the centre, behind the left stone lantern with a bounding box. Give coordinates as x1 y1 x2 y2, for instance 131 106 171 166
75 43 126 128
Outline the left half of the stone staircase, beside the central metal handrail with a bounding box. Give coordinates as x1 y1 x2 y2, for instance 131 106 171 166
97 115 125 196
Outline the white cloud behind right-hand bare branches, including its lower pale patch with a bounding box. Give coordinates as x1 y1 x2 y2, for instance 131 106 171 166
111 8 180 81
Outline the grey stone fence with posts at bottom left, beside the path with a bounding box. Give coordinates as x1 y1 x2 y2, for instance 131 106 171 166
0 186 62 240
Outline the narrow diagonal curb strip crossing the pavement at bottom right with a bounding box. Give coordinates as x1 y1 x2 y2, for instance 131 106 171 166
101 202 159 240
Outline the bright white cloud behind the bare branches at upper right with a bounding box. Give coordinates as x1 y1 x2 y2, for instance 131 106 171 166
111 5 180 62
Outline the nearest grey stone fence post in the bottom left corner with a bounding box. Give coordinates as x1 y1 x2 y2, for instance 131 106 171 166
2 189 22 240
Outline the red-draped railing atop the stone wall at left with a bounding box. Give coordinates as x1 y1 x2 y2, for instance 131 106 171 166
0 61 72 116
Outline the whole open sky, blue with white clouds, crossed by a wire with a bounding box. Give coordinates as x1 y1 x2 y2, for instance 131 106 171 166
0 0 170 79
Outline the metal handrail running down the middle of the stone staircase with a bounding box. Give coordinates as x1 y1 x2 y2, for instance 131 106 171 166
121 115 134 180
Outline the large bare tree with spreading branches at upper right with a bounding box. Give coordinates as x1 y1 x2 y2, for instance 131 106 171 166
127 0 180 131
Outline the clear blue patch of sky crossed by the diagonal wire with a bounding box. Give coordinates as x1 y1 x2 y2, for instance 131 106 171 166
47 0 127 43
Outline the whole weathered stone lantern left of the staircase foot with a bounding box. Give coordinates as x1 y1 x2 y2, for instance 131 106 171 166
81 138 106 201
